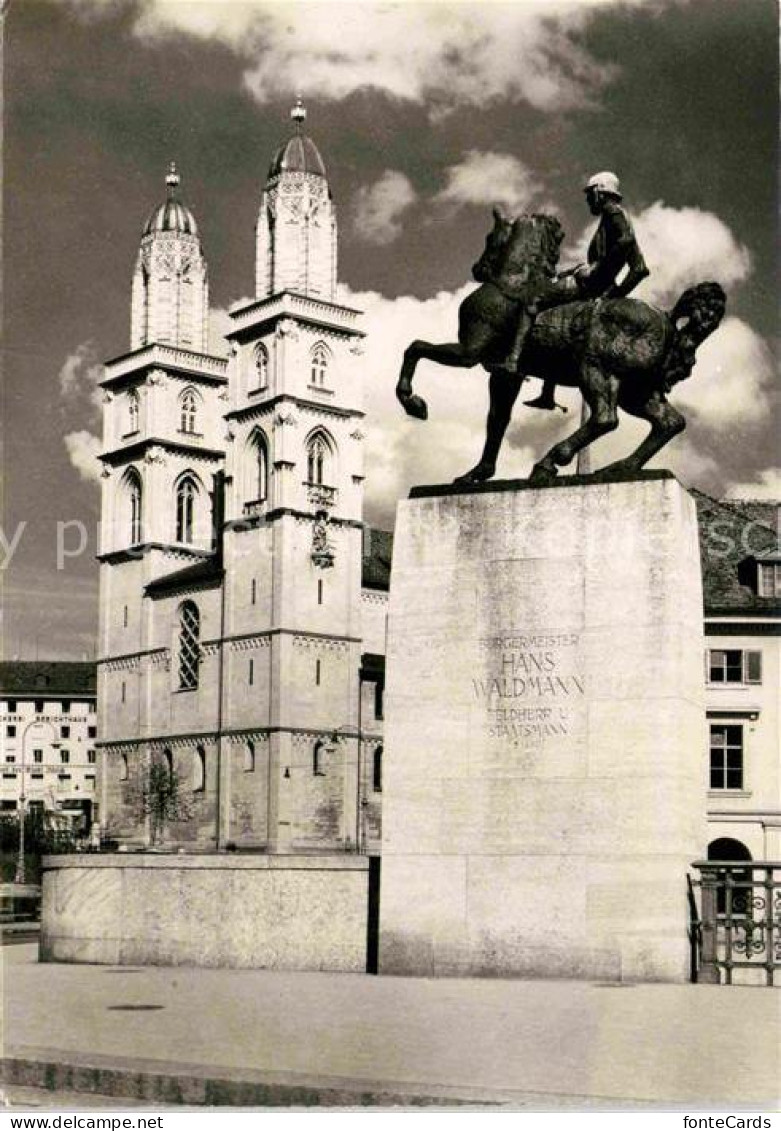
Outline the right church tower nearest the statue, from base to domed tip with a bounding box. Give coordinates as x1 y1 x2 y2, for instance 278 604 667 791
222 102 364 853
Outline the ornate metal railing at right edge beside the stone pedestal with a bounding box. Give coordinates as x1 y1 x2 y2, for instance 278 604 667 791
689 860 781 986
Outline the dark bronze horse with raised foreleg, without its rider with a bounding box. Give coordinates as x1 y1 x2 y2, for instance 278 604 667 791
396 209 726 483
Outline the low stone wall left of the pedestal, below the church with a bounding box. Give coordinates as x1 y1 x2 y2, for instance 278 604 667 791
41 853 368 973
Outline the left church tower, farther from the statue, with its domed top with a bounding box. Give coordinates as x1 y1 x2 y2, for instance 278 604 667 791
98 164 227 838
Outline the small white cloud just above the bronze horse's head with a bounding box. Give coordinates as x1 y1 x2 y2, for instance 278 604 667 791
434 149 543 211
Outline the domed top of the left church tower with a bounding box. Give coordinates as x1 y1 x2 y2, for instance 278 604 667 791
130 162 209 353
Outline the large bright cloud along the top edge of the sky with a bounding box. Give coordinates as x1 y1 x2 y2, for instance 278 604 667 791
71 0 614 114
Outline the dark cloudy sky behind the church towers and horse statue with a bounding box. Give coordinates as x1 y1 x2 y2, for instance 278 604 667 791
0 0 781 659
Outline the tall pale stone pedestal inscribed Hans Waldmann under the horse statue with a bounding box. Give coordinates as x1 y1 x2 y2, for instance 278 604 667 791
380 472 706 982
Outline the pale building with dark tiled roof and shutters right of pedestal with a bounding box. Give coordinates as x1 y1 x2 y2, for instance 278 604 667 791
692 491 781 860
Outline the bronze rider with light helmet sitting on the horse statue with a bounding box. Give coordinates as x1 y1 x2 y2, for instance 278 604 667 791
502 172 649 409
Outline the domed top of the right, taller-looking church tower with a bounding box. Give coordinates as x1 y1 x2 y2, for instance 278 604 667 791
255 98 337 301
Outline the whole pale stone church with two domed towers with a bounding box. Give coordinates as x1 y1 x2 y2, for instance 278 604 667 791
98 105 390 853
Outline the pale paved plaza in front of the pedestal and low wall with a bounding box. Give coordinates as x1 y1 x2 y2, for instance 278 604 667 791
2 943 781 1111
